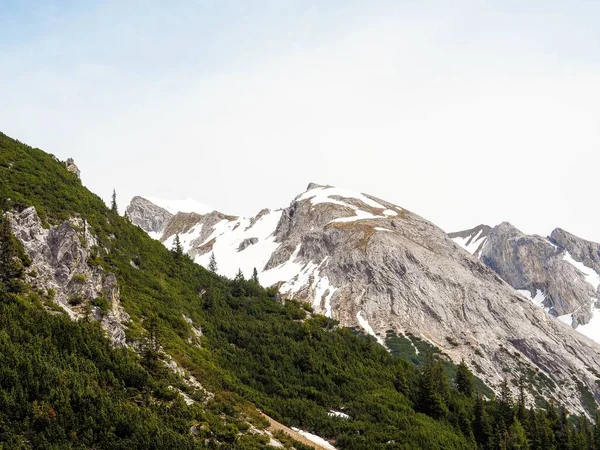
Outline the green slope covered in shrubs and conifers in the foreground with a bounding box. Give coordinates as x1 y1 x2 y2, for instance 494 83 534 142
0 134 600 450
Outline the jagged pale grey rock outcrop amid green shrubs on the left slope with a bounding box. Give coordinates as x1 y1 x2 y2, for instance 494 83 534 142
9 207 129 346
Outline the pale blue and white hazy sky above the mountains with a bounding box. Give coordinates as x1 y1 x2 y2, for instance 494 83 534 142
0 0 600 241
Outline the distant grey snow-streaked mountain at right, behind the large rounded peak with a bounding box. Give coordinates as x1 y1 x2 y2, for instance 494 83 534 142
449 222 600 342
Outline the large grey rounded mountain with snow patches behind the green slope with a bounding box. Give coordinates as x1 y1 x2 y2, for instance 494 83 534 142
127 184 600 413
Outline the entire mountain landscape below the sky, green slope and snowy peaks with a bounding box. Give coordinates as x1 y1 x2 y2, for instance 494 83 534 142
0 133 600 450
